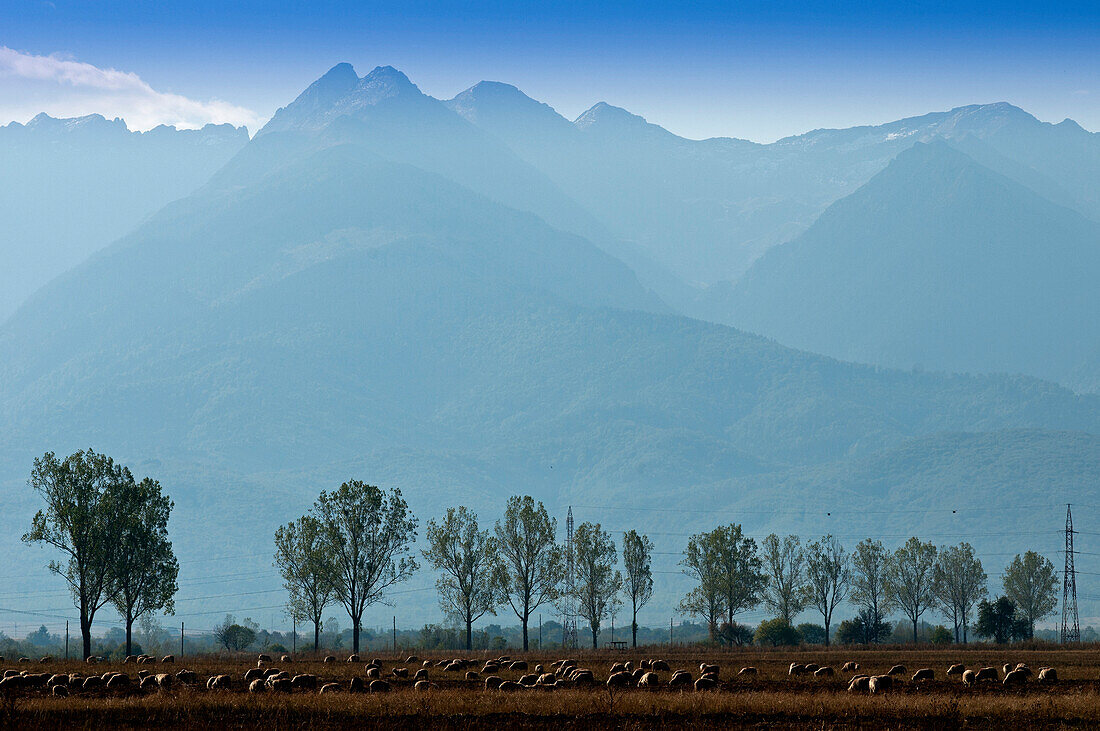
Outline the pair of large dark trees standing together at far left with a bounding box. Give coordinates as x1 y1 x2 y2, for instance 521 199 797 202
23 450 179 657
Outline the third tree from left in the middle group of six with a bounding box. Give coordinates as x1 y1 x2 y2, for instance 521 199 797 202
424 506 504 650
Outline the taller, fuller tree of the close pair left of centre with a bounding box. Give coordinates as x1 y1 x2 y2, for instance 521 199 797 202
314 479 419 653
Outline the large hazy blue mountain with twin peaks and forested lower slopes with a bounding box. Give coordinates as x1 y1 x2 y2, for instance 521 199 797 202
0 66 1100 621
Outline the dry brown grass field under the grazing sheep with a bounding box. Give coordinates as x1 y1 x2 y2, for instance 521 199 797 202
0 647 1100 730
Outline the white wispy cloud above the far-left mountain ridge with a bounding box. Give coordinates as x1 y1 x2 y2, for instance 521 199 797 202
0 46 263 132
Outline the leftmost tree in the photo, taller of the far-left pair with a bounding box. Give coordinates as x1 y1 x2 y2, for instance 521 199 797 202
23 450 133 657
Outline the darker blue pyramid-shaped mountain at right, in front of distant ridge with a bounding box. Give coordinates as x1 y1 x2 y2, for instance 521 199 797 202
712 142 1100 389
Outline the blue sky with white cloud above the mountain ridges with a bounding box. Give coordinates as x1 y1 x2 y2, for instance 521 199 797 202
0 0 1100 142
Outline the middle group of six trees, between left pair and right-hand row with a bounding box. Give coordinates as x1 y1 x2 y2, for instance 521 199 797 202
275 490 653 652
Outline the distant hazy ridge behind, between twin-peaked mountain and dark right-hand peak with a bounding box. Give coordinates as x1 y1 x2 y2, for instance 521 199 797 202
447 81 1100 292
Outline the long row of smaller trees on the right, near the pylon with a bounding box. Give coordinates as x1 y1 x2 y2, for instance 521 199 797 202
680 524 1057 645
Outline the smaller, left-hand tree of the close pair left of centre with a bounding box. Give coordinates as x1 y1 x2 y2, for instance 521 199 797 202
275 516 334 651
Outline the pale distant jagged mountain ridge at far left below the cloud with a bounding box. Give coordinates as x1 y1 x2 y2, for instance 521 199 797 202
0 114 249 321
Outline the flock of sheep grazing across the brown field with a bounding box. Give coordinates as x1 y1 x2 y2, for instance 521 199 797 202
0 655 1058 697
